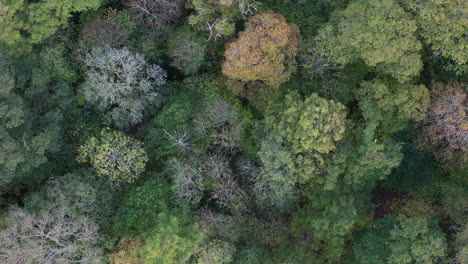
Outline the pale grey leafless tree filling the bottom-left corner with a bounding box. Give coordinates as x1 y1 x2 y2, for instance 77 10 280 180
0 204 102 264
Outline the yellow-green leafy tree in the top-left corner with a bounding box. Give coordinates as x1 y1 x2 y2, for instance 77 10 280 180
0 0 103 47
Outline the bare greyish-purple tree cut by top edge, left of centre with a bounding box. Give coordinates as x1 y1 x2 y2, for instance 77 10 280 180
124 0 183 28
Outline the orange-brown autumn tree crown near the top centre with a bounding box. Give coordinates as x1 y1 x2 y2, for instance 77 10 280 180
222 11 299 86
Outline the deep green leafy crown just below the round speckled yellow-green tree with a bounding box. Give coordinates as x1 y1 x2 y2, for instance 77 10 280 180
113 173 173 236
